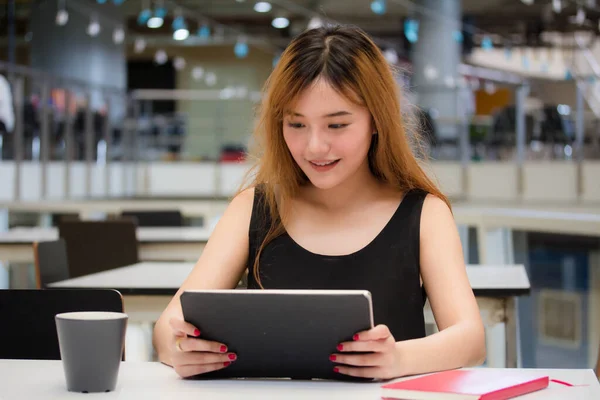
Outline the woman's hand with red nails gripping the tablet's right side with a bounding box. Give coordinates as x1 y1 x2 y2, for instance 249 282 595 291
329 325 400 379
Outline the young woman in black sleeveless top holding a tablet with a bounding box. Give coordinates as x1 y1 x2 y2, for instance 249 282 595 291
154 27 485 379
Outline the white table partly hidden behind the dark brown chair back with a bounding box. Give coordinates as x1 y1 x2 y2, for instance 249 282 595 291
0 227 211 263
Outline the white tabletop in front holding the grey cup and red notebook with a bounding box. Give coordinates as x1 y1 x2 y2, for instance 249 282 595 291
0 360 600 400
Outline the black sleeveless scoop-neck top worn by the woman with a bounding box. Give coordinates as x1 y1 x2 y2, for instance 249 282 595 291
248 188 427 341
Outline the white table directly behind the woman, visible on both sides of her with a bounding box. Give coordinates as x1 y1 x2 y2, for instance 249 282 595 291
50 262 530 367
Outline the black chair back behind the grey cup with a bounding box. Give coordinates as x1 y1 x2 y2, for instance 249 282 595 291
0 289 123 360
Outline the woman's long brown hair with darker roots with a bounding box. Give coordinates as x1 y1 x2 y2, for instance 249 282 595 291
242 26 450 286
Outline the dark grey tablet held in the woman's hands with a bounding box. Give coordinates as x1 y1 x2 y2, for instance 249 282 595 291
181 289 373 380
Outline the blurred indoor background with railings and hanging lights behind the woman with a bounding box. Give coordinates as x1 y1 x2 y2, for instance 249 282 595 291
0 0 600 368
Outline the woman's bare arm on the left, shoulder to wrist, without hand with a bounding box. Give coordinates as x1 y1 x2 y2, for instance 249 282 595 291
153 189 254 365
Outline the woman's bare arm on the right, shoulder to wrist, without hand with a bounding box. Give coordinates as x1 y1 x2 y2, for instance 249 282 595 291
396 195 485 376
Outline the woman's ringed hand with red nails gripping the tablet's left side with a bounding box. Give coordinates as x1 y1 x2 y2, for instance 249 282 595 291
169 317 237 378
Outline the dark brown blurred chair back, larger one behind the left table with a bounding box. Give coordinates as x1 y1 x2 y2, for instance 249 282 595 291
58 219 139 278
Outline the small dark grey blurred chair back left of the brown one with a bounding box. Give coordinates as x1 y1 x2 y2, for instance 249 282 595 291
33 239 69 289
